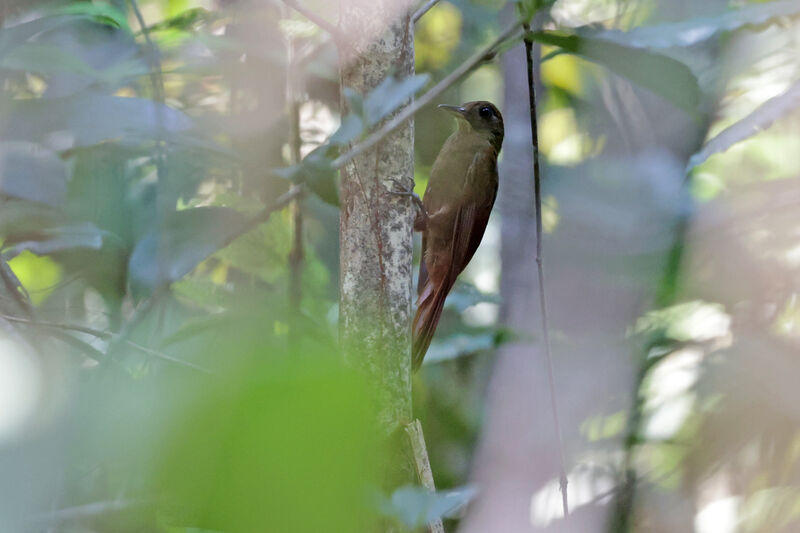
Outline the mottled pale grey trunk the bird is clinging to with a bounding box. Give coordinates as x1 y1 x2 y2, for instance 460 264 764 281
339 0 414 433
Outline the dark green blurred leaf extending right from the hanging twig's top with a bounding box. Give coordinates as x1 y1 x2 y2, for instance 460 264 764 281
529 32 700 117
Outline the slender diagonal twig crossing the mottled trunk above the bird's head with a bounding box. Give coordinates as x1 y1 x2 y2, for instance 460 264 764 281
331 23 519 168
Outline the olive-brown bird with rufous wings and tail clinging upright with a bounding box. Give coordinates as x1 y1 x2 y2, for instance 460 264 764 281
412 101 503 369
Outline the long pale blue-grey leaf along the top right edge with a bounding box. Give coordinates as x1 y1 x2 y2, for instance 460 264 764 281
580 0 800 48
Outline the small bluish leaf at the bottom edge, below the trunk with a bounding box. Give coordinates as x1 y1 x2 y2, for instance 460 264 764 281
381 486 478 528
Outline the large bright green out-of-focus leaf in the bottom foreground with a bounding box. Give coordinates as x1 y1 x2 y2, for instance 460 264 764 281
160 354 380 533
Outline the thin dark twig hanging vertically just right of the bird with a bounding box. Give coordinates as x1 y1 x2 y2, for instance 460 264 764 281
524 23 569 516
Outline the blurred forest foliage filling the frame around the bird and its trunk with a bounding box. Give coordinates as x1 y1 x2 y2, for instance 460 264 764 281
0 0 800 533
